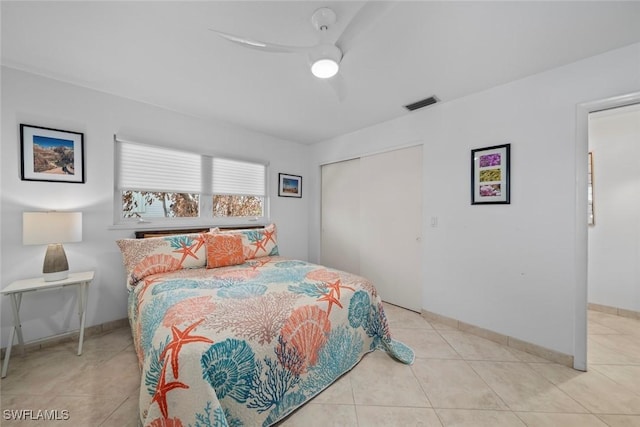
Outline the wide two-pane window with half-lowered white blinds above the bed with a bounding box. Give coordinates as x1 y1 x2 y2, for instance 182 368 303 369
115 139 267 224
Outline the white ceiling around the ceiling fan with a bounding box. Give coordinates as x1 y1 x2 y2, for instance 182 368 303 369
1 1 640 144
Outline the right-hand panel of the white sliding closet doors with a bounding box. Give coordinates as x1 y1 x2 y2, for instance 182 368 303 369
360 146 422 312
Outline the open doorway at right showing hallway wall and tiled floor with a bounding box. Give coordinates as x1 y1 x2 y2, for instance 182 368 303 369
587 104 640 369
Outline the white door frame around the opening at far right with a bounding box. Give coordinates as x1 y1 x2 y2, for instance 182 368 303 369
573 92 640 371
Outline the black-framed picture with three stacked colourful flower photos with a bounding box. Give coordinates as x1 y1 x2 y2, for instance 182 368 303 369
471 144 511 205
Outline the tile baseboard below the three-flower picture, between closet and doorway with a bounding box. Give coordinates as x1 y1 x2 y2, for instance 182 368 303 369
421 309 573 368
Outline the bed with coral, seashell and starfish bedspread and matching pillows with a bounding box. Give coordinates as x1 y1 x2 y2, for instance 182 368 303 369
117 224 413 427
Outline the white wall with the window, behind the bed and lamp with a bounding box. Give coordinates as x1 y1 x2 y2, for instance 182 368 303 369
0 67 309 347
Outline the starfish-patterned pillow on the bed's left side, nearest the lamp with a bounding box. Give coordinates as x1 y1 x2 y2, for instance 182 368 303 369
116 233 207 286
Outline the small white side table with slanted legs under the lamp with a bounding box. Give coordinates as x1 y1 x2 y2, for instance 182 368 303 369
0 271 95 378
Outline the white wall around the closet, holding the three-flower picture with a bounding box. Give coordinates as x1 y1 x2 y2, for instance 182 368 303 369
309 44 640 355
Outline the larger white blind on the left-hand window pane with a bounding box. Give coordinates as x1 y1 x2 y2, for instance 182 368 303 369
117 141 202 193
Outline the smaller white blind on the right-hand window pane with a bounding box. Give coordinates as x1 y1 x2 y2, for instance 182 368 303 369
211 158 266 197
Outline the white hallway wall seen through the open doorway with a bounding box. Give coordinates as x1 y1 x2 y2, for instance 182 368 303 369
589 105 640 311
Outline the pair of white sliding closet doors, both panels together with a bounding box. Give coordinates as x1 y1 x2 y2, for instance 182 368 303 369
320 146 422 311
